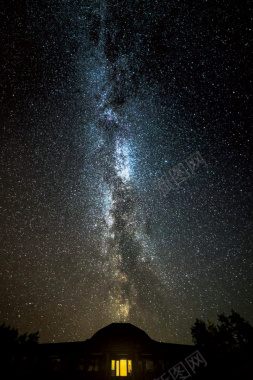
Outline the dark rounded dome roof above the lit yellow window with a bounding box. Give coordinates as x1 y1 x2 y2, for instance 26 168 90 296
87 323 155 349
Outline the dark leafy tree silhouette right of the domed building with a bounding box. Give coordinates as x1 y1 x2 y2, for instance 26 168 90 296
191 310 253 380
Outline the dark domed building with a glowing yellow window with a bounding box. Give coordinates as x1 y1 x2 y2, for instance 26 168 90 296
9 323 194 380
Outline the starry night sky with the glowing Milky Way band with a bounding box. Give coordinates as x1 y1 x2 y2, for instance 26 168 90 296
0 0 253 344
